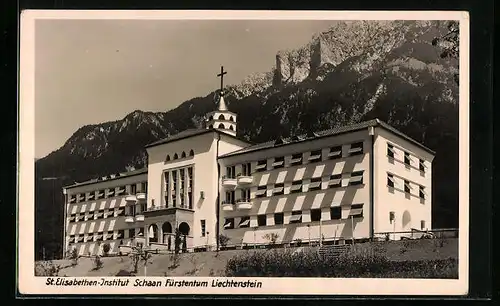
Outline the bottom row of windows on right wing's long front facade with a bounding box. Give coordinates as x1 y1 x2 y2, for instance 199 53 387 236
224 204 363 229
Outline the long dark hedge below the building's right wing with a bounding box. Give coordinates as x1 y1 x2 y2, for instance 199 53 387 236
226 249 458 278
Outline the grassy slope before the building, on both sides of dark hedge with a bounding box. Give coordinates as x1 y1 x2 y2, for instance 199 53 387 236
41 239 458 277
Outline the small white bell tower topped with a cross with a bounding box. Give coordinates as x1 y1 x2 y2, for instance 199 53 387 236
206 66 236 136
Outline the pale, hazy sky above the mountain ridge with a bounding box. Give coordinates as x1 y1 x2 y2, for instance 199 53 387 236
35 20 335 158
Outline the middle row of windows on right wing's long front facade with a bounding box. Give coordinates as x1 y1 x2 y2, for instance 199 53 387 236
223 170 364 204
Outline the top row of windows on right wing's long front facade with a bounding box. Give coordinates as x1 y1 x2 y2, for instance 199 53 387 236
225 142 363 178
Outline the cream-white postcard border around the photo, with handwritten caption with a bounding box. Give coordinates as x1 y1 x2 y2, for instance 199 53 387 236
17 10 469 295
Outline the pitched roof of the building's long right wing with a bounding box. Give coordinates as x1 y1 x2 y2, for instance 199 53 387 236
220 119 435 158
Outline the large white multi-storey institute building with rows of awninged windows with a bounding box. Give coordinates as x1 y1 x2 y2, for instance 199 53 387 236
63 68 434 254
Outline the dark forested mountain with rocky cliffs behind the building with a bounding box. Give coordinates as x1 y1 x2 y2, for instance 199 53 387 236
35 21 458 258
